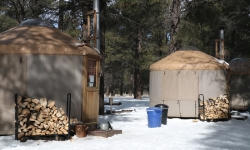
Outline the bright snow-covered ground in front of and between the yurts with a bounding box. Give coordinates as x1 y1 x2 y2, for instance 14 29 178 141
0 98 250 150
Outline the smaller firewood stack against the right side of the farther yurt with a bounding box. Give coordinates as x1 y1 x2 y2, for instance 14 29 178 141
199 95 229 120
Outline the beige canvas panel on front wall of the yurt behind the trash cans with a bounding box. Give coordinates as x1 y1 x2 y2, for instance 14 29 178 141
161 70 198 117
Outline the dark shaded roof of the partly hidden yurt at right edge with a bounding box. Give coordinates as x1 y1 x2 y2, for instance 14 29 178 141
229 58 250 74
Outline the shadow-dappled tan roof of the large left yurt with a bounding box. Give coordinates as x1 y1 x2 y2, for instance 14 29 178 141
0 25 100 56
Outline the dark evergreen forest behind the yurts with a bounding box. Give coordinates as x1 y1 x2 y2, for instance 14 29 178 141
0 0 250 114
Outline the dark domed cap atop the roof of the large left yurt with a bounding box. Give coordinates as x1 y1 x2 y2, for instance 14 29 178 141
19 19 55 28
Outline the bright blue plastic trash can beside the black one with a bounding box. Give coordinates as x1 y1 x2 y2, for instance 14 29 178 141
147 107 162 128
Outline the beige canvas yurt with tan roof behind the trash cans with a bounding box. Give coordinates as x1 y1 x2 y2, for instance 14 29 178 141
150 50 228 118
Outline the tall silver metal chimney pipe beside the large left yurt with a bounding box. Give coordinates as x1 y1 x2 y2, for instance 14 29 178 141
93 0 100 51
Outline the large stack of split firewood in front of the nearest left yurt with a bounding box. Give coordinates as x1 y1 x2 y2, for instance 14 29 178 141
17 96 69 138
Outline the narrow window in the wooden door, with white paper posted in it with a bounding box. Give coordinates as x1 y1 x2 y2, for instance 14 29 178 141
87 59 96 86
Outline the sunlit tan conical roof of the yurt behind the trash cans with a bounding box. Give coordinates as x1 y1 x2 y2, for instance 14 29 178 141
150 50 229 71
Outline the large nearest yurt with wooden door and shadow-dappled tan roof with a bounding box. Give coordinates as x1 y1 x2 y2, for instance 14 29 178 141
0 20 100 135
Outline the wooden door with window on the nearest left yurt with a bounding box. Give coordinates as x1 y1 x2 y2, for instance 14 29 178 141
83 57 100 122
